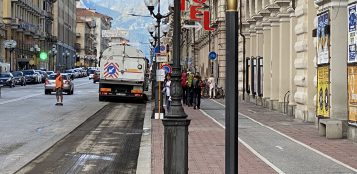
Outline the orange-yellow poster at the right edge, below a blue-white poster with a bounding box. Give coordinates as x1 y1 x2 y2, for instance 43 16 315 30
348 66 357 122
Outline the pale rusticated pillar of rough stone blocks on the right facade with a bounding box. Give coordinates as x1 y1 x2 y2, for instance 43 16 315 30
294 0 316 122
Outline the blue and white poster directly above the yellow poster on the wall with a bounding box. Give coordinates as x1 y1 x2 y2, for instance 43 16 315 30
317 12 330 65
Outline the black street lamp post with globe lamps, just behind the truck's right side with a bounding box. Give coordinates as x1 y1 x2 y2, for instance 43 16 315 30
144 0 170 115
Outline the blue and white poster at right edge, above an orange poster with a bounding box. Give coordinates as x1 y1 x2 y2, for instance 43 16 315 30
348 4 357 63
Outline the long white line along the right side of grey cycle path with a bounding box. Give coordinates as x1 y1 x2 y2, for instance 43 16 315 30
205 99 357 172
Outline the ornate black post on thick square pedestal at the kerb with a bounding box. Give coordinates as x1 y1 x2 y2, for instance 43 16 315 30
162 0 191 174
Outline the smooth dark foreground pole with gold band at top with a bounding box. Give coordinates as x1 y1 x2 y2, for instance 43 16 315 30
225 0 238 174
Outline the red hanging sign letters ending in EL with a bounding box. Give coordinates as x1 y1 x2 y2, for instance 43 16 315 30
181 0 214 31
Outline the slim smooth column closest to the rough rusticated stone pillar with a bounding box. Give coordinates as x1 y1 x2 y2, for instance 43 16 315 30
288 6 296 115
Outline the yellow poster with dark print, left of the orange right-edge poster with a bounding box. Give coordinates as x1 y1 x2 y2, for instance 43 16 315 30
316 66 330 117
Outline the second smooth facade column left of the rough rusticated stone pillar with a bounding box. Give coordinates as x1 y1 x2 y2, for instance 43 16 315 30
268 4 280 110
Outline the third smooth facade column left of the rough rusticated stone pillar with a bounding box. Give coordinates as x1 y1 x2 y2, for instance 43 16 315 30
260 9 271 106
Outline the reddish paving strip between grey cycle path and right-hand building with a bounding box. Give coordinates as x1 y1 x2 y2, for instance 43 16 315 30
239 102 357 169
